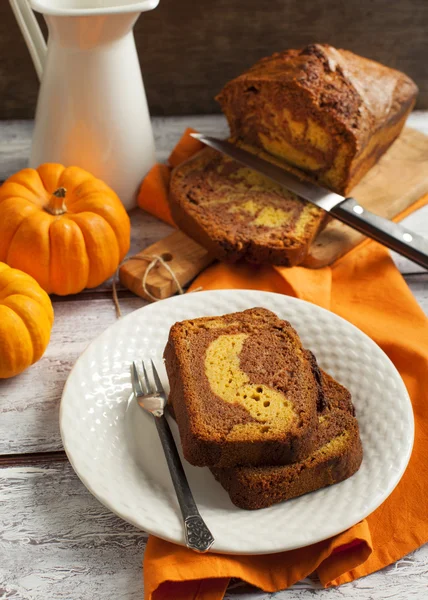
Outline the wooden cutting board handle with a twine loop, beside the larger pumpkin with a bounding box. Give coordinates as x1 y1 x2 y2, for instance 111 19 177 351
119 231 214 300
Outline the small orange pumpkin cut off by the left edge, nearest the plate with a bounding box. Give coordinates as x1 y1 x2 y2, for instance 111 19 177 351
0 262 54 379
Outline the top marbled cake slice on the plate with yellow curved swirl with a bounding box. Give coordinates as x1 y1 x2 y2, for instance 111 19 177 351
164 308 323 467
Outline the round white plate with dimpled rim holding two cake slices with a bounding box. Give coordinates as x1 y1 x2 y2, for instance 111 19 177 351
60 290 414 554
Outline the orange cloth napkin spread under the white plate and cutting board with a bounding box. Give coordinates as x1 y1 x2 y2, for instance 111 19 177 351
139 130 428 600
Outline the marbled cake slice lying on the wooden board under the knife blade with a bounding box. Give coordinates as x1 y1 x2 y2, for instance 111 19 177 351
169 148 325 266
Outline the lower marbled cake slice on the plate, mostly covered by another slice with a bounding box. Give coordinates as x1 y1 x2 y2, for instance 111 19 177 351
211 373 363 510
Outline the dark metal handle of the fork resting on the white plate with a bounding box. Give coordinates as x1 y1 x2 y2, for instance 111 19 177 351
153 415 214 552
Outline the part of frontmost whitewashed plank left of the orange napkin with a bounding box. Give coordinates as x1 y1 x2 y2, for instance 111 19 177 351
0 463 147 600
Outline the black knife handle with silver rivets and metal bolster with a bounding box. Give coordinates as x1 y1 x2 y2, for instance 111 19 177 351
329 198 428 269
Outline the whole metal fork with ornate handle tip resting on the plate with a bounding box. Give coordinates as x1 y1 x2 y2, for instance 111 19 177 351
131 361 214 552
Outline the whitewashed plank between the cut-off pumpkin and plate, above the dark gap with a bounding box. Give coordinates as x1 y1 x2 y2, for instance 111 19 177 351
0 296 146 454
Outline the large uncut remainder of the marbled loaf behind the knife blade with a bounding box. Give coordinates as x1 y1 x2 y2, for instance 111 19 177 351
217 44 418 194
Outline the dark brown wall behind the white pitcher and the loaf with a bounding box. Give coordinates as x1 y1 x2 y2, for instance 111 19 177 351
0 0 428 119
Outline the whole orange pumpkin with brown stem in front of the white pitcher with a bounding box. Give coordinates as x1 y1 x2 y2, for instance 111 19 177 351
0 163 130 295
